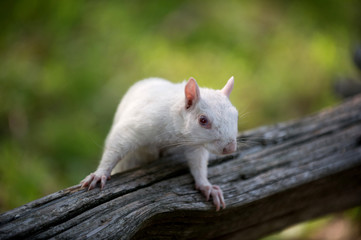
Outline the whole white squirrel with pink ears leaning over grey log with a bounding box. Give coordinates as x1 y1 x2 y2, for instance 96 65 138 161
81 77 238 211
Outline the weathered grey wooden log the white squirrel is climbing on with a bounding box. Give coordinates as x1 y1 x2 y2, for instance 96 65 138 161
0 96 361 239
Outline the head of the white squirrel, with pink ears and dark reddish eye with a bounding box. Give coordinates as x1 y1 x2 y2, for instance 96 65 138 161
183 77 238 155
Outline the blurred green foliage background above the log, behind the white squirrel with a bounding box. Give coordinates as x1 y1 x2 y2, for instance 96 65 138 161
0 0 361 238
